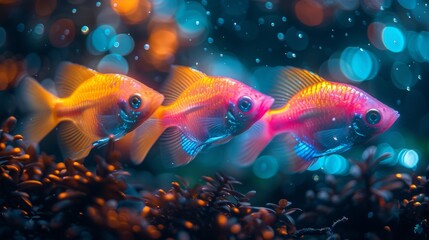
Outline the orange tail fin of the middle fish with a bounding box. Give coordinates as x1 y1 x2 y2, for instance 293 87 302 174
130 117 165 164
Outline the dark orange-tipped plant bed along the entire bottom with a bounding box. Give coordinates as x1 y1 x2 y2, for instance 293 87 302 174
0 117 429 239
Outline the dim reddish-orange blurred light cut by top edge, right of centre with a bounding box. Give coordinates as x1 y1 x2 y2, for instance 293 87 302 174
295 0 324 26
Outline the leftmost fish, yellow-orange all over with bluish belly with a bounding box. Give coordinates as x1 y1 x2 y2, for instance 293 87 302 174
19 63 164 159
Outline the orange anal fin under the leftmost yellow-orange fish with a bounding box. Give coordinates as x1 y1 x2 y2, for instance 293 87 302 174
58 121 95 160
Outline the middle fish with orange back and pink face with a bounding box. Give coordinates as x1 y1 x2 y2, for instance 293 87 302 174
131 66 274 166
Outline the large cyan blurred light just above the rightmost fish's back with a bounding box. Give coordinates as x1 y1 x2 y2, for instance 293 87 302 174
340 47 379 82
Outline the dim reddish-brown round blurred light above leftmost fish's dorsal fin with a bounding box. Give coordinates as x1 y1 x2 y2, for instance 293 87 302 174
49 18 76 48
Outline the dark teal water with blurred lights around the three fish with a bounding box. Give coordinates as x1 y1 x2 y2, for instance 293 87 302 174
0 0 429 238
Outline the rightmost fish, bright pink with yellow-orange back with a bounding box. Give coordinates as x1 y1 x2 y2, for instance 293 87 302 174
229 67 399 171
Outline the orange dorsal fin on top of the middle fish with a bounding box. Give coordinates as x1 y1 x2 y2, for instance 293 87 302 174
161 66 207 105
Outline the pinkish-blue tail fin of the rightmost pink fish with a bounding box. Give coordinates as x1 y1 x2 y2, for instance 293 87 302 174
227 117 273 166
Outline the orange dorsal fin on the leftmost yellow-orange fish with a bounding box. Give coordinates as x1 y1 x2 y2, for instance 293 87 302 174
55 62 98 97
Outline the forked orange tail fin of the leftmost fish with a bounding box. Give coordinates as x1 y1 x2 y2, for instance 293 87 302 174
18 77 57 144
